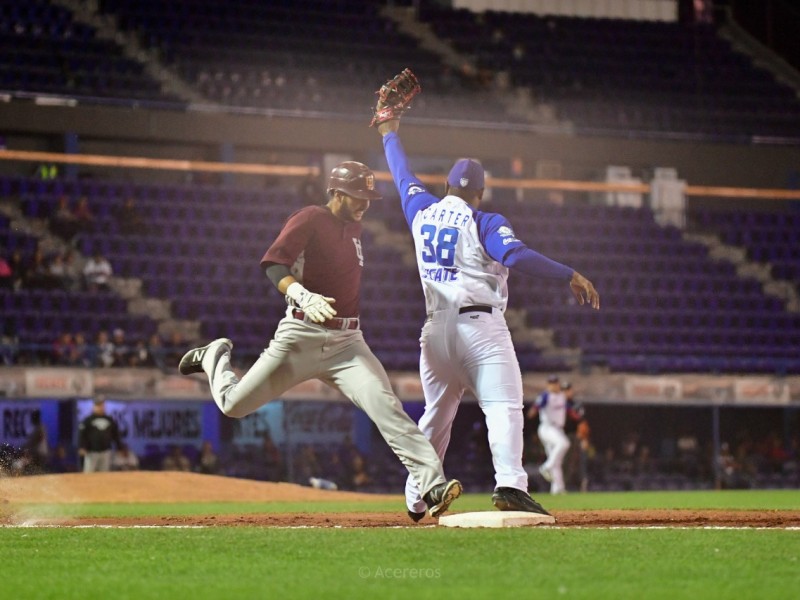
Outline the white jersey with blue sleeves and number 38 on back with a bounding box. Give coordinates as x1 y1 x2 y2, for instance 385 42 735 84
383 132 573 313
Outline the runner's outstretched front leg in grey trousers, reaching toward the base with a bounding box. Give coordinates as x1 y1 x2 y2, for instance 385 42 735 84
320 330 445 493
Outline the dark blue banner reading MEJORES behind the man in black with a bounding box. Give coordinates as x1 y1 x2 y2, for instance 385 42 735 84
75 400 204 454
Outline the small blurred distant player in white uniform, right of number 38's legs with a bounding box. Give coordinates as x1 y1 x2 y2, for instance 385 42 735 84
527 375 580 494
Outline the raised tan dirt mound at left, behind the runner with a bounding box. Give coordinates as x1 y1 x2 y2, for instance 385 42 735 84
0 471 398 504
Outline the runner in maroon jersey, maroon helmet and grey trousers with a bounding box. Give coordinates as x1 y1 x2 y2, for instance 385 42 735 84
179 161 461 517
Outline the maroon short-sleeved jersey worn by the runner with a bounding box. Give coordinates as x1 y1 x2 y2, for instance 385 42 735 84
261 206 364 318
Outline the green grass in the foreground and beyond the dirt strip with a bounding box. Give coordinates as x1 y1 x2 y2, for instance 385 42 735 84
0 491 800 600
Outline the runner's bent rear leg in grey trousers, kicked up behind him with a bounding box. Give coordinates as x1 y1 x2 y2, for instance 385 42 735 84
212 318 328 418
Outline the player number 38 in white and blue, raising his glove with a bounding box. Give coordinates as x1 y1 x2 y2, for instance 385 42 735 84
372 70 600 514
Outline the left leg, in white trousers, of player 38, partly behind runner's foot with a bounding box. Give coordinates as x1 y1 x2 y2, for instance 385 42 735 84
406 323 464 513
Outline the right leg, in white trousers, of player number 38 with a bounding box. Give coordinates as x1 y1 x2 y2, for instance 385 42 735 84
459 313 528 492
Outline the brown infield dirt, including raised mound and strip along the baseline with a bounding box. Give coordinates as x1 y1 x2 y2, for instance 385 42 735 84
0 471 800 528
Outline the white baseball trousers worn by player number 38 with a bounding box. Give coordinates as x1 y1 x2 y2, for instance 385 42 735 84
406 308 528 512
